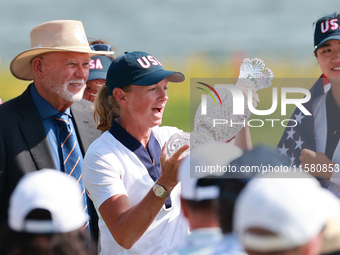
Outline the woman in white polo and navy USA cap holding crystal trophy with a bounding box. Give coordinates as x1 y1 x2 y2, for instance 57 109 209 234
83 52 188 255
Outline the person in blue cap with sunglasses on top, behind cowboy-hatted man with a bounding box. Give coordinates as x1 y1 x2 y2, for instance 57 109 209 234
83 40 114 103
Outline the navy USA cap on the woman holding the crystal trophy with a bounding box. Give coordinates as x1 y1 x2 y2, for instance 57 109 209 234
106 51 185 95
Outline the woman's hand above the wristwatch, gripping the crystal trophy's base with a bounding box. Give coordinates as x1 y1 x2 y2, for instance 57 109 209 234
157 143 189 192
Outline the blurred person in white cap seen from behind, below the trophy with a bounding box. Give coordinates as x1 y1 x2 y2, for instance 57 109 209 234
168 142 242 255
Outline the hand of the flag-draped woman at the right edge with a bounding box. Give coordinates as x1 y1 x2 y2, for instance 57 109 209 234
299 149 334 179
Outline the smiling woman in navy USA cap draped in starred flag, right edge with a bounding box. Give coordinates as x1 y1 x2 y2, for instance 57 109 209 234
278 12 340 197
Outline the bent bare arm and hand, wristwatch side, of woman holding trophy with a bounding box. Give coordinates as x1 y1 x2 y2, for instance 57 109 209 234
99 141 189 249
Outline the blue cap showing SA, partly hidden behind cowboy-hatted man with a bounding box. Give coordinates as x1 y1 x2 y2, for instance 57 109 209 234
87 55 112 81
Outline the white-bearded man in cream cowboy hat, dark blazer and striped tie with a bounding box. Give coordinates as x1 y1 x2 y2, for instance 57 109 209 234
0 20 113 241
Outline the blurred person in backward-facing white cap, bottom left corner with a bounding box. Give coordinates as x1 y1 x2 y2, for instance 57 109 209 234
0 169 96 255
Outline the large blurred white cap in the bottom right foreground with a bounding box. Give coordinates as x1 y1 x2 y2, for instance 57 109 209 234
234 172 340 252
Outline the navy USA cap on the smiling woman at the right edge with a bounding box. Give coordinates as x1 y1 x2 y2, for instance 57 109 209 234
314 12 340 52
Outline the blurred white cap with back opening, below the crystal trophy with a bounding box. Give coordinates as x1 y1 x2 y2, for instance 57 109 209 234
178 142 243 201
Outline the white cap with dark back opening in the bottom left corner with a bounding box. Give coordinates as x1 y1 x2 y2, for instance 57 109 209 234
8 169 88 233
